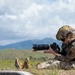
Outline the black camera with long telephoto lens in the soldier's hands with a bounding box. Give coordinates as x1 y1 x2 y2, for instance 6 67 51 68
32 42 60 53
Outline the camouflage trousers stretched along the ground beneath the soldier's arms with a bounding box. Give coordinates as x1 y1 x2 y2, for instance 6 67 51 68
36 60 75 70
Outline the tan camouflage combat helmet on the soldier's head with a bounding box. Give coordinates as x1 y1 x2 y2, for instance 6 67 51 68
56 25 75 40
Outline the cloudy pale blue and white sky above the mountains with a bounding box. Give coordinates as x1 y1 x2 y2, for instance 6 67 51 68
0 0 75 45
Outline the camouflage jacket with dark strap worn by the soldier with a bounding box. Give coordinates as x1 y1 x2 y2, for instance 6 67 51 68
59 39 75 61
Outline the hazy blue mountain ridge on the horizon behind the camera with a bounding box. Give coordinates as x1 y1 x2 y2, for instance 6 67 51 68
0 38 61 49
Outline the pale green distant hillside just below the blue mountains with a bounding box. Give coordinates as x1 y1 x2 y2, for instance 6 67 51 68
0 49 53 60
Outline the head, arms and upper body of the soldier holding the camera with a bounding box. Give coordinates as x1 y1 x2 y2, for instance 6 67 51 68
45 26 75 61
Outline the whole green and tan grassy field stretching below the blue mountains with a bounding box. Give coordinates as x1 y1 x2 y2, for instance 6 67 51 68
0 49 75 75
